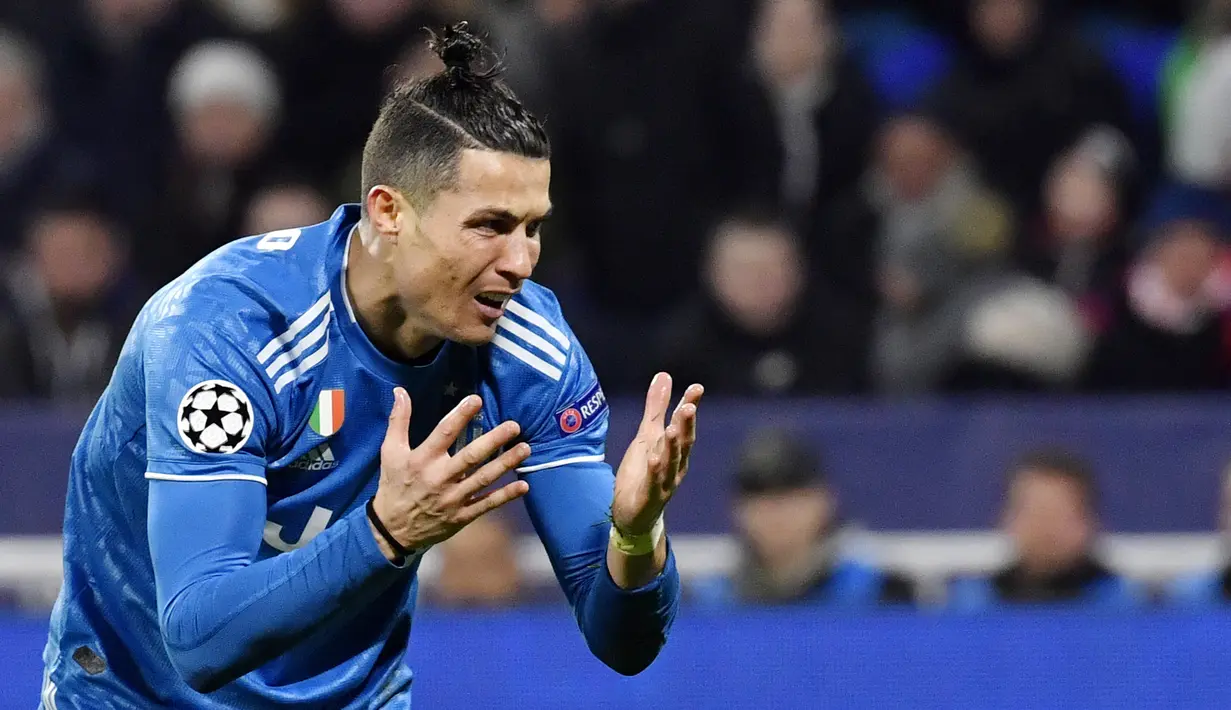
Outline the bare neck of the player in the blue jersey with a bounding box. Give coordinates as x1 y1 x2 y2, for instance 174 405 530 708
342 225 443 362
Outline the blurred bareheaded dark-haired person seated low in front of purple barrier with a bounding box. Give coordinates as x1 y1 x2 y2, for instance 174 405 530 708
949 452 1147 612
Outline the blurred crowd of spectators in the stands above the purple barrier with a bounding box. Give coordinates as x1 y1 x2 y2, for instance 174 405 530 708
0 0 1231 401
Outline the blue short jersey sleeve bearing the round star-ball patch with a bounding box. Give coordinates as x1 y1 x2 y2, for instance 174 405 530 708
142 279 284 484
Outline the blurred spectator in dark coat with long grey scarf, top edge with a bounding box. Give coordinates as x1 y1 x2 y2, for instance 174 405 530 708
725 0 879 226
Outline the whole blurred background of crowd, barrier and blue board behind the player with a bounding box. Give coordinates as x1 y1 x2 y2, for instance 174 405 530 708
0 0 1231 709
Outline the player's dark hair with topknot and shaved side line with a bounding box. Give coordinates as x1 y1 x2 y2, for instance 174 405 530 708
361 22 550 207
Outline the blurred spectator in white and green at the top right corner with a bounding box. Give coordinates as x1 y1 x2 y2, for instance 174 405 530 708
1163 0 1231 191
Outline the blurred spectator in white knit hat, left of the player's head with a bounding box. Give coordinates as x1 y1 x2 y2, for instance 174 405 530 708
138 41 282 285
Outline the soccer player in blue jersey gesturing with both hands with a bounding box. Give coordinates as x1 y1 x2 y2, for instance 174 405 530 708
42 26 702 710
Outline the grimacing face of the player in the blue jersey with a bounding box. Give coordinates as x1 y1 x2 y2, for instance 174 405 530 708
393 150 551 346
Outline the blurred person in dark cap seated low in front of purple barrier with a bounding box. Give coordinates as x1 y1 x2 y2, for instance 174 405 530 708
689 429 915 608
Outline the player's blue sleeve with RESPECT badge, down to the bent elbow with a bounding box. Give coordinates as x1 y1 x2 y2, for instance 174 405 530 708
492 285 680 676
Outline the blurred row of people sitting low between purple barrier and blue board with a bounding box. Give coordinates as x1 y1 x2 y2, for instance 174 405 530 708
422 427 1231 613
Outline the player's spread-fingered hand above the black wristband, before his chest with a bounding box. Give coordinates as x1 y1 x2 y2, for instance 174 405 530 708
369 388 531 561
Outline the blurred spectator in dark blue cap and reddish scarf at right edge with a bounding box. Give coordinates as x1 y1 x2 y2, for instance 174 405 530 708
1088 182 1231 391
